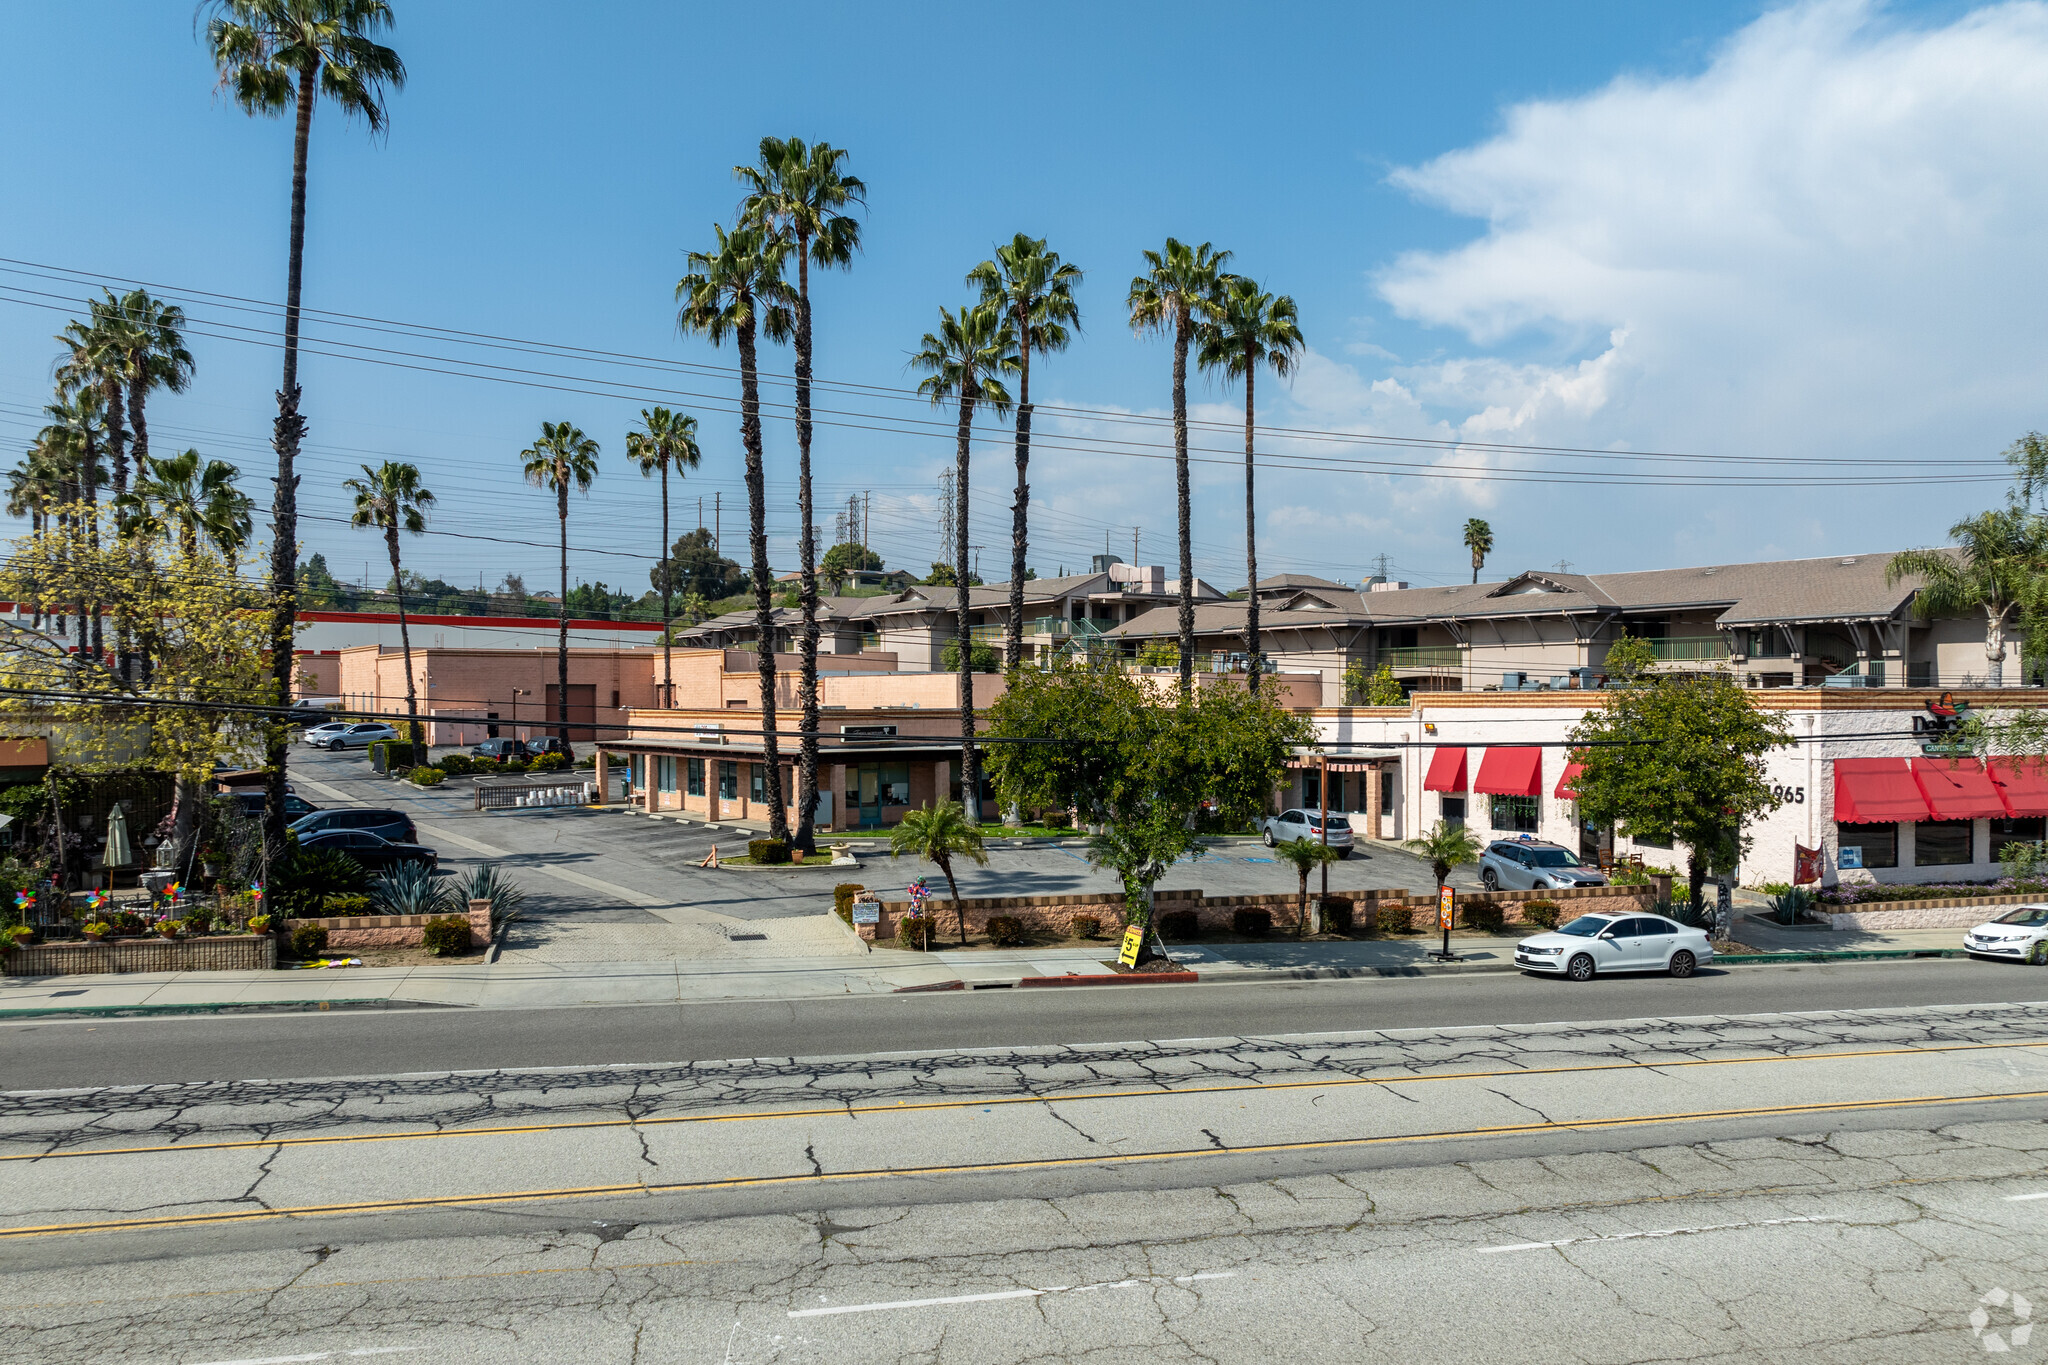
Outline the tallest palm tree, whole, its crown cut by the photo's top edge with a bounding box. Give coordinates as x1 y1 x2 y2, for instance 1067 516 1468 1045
207 0 406 868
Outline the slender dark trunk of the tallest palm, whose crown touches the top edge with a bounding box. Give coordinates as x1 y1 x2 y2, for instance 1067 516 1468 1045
262 57 319 880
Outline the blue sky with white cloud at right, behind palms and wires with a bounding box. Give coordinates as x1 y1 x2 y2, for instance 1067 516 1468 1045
0 0 2048 591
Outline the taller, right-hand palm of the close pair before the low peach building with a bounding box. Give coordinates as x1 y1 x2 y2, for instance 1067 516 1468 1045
733 137 868 853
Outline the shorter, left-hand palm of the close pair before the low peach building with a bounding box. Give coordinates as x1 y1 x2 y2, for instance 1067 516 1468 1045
676 223 797 841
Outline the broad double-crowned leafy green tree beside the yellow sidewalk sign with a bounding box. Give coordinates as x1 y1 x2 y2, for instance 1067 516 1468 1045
987 663 1315 925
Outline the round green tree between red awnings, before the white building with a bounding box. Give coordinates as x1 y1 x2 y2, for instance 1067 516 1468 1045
1569 671 1792 905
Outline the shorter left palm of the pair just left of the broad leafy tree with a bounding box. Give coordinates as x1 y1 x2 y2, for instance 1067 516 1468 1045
909 303 1018 825
